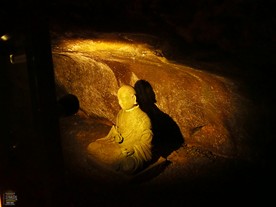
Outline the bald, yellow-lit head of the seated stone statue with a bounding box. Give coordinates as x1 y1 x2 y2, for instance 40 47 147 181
117 85 137 110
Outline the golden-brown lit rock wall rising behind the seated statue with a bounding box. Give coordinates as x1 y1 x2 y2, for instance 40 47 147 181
52 34 250 157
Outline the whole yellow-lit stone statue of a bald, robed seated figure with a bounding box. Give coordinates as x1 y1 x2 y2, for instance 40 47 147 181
87 85 153 175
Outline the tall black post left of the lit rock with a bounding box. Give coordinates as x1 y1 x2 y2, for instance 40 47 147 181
22 7 66 206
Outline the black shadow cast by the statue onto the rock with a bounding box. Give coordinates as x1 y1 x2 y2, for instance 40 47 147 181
134 80 184 158
